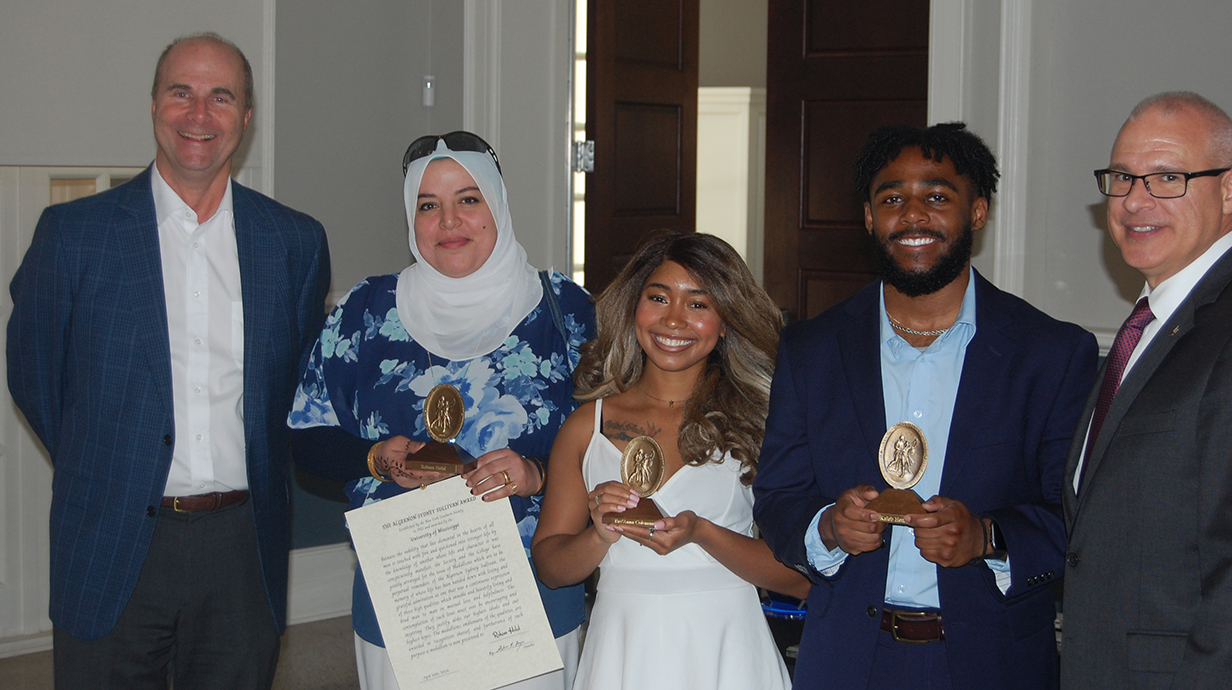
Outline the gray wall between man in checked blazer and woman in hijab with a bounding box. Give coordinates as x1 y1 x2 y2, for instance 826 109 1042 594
275 0 462 297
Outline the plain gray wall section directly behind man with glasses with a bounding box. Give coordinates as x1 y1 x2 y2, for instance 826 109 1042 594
1024 0 1232 330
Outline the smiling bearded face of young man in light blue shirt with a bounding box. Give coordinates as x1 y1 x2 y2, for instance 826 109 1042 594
864 147 988 297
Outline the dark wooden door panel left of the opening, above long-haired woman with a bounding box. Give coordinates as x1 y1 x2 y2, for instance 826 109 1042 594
584 0 699 294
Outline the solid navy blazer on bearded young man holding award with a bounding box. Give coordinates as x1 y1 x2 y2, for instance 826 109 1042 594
753 271 1096 690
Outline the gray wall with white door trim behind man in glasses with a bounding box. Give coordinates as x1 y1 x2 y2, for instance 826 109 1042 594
929 0 1232 350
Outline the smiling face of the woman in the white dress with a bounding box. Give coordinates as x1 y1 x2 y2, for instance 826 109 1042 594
633 261 727 373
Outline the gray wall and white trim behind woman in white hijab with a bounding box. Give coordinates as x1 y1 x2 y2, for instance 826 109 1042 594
275 0 570 296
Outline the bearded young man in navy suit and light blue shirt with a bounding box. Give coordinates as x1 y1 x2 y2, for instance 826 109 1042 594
753 123 1095 690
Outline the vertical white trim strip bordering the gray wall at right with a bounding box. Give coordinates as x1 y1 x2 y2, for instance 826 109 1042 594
993 0 1032 297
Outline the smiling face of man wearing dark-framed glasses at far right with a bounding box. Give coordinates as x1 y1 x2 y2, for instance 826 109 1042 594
1108 108 1232 288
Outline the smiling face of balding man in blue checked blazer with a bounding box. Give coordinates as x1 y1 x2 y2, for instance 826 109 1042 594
150 38 253 190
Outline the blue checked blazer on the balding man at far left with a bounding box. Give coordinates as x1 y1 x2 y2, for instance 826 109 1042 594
7 169 329 639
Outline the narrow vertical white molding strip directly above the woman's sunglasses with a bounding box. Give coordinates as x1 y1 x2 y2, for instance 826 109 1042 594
462 0 503 152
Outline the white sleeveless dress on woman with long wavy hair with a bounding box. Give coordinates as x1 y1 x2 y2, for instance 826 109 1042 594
573 400 791 690
